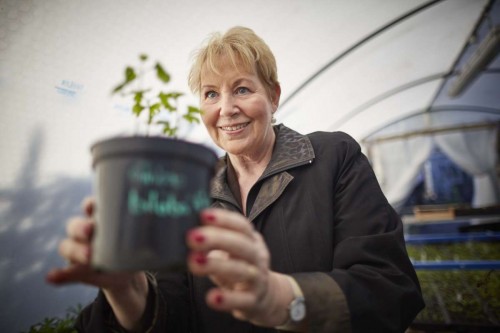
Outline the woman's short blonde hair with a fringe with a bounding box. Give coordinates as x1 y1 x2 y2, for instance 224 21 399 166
188 26 279 97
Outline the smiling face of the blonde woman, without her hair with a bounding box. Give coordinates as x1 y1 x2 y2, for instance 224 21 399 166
200 61 280 159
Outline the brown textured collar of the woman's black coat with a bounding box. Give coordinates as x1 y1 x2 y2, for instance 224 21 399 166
210 124 314 216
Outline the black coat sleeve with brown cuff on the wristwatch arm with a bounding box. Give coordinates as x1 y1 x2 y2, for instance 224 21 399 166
292 134 424 332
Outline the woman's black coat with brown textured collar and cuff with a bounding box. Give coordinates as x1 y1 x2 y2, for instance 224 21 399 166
76 125 423 333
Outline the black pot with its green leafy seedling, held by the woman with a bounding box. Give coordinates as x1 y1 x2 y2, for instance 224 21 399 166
91 54 217 271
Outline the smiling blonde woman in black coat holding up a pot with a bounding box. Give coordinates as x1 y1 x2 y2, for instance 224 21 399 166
48 27 423 332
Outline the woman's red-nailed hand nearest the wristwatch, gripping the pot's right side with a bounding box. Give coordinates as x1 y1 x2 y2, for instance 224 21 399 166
187 209 293 327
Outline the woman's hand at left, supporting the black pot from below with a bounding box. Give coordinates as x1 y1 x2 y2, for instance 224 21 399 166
46 199 149 330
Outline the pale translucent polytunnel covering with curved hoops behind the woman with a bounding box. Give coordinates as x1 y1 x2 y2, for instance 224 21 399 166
0 0 500 332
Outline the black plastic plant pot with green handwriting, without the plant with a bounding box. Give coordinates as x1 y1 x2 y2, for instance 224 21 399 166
91 136 217 271
